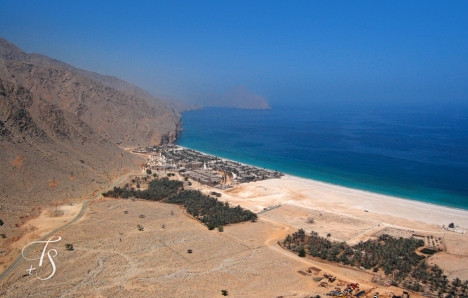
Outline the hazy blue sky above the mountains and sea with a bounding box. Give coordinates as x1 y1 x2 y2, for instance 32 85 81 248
0 0 468 104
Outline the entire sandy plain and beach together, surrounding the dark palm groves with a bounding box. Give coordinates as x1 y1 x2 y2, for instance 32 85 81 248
0 173 468 297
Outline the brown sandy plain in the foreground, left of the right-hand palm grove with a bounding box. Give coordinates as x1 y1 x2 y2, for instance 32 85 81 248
0 199 414 297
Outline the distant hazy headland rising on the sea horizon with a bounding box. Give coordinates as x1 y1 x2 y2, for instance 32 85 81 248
199 85 271 110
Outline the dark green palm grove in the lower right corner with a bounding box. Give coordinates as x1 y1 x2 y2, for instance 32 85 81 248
282 229 468 297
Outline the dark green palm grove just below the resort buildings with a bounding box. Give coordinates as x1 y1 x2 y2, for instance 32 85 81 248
102 177 257 230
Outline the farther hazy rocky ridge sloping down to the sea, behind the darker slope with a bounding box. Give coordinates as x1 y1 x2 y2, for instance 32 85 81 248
0 39 180 146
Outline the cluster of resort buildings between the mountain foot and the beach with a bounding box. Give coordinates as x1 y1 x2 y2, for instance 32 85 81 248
133 144 283 188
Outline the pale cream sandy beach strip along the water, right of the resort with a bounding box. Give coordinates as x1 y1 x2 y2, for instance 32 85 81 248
223 175 468 229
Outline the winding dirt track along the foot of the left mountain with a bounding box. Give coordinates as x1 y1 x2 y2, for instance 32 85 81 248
0 172 141 281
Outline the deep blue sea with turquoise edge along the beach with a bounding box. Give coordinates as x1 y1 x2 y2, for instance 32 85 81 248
178 106 468 209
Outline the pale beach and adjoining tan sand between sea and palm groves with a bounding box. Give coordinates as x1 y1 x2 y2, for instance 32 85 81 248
200 175 468 280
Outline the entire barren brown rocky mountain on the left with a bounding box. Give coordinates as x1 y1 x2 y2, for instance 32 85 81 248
0 38 180 263
